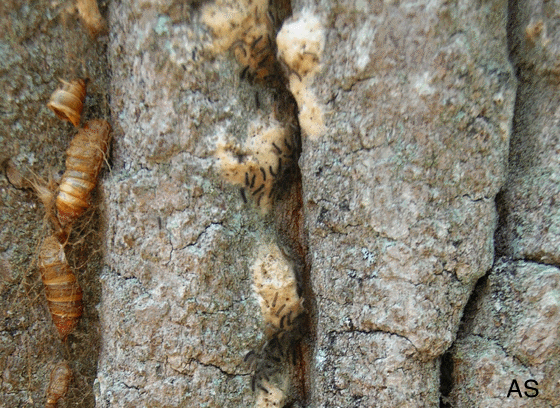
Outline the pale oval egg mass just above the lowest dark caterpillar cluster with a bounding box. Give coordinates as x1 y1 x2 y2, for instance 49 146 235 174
253 244 304 330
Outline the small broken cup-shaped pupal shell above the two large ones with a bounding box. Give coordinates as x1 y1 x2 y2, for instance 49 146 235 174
47 78 86 127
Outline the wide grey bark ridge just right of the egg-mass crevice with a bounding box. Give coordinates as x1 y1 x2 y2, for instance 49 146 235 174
302 1 516 407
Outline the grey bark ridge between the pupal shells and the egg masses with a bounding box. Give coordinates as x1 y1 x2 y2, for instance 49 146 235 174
96 2 276 407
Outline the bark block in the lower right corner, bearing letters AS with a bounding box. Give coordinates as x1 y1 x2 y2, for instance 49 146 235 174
446 261 560 407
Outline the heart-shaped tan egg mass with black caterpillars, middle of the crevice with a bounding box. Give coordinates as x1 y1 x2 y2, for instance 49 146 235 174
216 117 301 211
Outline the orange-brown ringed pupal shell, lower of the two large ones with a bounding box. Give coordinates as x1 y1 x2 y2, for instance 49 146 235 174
39 236 83 339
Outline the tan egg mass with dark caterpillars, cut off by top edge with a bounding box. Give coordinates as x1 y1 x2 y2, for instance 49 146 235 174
203 0 282 87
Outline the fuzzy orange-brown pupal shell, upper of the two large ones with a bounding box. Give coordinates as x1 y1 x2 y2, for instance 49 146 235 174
56 119 111 225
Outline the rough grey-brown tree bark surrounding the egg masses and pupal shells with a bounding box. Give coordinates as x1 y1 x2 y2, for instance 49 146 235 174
0 0 560 407
